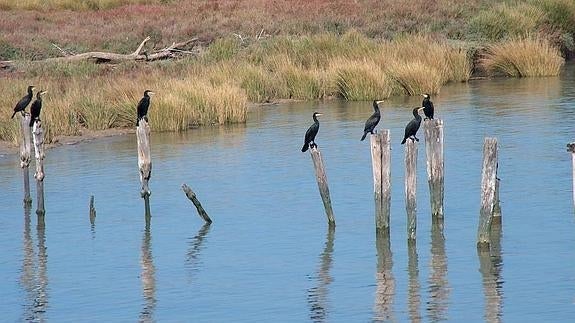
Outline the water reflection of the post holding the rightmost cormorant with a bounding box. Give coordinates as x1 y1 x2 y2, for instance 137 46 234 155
427 217 449 322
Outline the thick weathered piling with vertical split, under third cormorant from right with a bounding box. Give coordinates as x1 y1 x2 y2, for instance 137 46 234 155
370 129 391 230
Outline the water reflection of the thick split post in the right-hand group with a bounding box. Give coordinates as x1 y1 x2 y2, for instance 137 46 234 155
373 230 395 322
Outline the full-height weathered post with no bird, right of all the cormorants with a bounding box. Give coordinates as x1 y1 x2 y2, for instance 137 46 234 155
477 137 497 248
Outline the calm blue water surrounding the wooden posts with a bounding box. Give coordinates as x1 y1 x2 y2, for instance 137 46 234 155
0 66 575 322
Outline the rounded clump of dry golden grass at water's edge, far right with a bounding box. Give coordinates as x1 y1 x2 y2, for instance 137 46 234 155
481 37 564 77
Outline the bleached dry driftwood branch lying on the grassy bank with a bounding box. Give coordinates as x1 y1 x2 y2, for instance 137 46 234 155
44 37 200 63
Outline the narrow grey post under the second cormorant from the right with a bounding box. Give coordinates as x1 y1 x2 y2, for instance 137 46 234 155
405 139 417 239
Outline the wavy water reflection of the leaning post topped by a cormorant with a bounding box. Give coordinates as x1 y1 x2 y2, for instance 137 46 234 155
307 225 335 322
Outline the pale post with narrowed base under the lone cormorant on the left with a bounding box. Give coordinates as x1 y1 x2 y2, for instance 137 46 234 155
136 118 152 206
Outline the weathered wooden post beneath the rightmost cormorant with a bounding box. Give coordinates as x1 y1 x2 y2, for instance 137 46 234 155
423 119 444 218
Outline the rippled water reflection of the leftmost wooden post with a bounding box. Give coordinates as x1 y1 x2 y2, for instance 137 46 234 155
20 204 36 322
